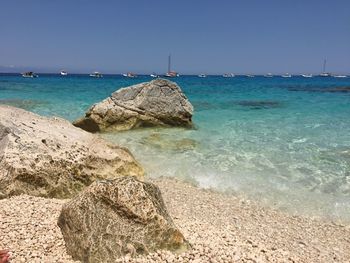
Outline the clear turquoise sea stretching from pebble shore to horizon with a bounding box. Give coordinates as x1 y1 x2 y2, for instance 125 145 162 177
0 74 350 222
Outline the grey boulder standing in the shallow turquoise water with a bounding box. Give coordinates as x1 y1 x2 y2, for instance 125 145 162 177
73 79 193 132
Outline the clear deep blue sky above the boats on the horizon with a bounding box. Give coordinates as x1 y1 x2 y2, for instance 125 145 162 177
0 0 350 74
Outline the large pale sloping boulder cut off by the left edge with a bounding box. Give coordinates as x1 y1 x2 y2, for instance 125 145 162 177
0 105 143 198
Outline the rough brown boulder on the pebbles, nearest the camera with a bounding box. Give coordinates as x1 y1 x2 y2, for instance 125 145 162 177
58 177 189 263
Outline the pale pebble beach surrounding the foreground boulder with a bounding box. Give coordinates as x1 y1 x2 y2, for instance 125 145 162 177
0 178 350 263
